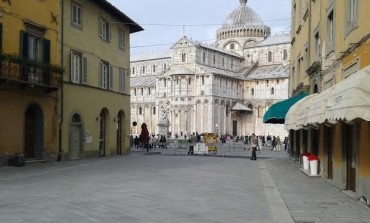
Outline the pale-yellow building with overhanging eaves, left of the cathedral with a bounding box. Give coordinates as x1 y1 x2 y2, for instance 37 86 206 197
59 0 143 160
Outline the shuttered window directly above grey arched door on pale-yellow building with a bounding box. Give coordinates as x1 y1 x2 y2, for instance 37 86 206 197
71 51 87 84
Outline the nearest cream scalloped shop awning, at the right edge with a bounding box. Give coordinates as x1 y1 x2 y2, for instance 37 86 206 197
325 66 370 122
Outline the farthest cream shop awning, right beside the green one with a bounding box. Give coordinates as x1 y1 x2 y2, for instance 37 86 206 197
285 94 317 130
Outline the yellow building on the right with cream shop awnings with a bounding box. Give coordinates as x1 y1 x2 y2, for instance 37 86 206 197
286 0 370 204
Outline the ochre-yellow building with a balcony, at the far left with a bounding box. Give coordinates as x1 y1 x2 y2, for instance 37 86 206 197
0 0 63 165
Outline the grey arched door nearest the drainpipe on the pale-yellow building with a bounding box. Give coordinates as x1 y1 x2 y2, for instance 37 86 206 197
69 114 82 160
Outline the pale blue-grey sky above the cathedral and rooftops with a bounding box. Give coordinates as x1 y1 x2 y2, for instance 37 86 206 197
108 0 291 54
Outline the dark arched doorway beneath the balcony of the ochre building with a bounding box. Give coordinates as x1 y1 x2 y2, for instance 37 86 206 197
24 104 44 159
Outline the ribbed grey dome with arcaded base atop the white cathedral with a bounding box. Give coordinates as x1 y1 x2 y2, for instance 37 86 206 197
217 0 270 40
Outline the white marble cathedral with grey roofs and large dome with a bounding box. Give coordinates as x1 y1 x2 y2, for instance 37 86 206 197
130 0 290 137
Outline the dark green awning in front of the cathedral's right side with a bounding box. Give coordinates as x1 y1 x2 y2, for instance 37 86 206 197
263 93 308 124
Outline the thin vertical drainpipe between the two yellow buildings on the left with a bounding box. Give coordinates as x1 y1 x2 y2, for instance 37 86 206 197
58 0 64 162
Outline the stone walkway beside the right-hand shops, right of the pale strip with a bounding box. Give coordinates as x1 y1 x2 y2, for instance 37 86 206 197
265 159 370 223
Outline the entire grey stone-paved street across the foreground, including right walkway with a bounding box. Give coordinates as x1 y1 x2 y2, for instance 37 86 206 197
0 149 370 223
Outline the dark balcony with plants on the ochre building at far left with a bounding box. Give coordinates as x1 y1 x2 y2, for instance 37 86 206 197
0 54 63 93
